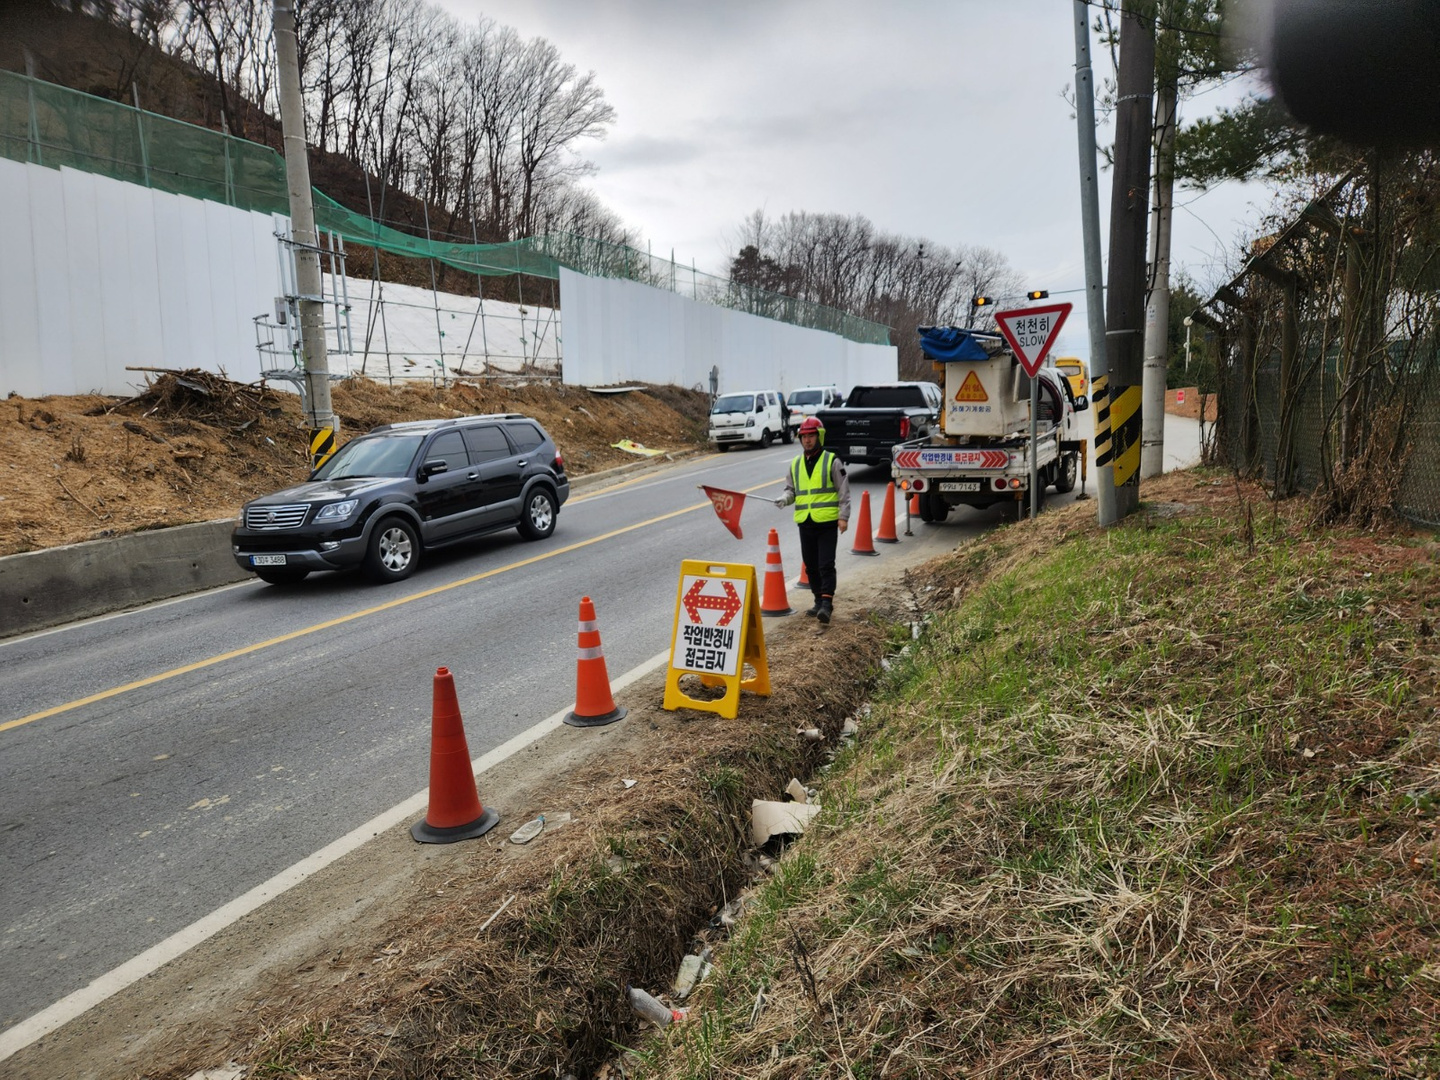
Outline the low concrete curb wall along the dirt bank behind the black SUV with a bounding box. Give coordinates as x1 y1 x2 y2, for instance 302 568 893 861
0 455 696 638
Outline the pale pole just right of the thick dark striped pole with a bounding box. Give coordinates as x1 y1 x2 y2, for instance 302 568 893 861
1140 59 1176 480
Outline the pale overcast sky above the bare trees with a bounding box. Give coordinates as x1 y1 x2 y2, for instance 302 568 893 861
439 0 1267 364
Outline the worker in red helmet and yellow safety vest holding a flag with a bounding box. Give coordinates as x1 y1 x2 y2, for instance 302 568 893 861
776 416 850 622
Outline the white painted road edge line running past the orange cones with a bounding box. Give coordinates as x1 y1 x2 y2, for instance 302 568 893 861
0 648 670 1061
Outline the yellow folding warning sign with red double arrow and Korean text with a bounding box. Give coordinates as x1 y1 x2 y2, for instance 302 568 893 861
664 559 770 720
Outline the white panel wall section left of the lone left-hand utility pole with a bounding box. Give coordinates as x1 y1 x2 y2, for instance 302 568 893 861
0 158 279 397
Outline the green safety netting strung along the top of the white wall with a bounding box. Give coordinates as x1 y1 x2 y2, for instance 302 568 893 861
0 71 890 344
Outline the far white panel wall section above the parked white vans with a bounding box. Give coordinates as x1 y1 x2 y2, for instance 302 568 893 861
560 269 900 393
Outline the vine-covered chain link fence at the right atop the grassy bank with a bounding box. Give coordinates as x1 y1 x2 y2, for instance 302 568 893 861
1197 173 1440 527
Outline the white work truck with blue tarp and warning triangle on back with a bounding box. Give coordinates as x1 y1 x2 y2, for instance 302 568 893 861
891 327 1090 521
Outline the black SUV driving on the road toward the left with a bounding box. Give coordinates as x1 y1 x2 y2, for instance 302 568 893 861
230 413 570 585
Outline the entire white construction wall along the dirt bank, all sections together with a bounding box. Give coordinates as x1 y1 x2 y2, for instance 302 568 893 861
0 158 897 397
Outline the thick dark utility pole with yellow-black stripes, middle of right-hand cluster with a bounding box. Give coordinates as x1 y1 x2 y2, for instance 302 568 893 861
1096 0 1155 520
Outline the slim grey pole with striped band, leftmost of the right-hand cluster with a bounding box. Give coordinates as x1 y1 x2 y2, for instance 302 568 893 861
1074 0 1116 526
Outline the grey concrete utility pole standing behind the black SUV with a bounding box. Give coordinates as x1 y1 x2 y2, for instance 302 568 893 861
275 0 340 468
